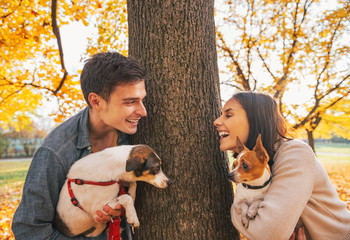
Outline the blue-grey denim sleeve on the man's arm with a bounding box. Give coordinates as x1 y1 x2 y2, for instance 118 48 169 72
12 147 107 240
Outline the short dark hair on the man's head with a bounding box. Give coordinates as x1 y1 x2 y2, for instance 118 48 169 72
80 52 146 106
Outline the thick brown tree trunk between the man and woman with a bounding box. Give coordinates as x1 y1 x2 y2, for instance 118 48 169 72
127 0 239 240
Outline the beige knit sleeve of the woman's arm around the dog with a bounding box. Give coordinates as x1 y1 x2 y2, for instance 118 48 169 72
231 140 316 240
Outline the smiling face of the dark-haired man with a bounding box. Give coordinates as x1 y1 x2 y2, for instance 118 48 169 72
100 81 147 134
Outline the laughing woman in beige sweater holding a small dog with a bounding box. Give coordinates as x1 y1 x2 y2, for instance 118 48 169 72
214 92 350 240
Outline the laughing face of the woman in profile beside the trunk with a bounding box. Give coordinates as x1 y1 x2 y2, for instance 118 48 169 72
214 98 249 151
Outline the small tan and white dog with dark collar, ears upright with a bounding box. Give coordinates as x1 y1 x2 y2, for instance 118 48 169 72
229 134 271 228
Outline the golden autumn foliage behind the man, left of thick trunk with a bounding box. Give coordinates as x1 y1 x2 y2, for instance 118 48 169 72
0 0 127 129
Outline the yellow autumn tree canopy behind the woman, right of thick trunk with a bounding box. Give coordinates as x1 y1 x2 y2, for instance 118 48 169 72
217 0 350 149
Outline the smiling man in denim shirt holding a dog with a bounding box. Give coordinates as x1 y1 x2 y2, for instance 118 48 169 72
12 52 147 240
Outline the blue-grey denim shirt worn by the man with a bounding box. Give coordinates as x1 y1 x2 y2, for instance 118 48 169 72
12 108 128 240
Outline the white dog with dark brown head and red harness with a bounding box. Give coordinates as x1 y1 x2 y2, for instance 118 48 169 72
54 145 170 237
